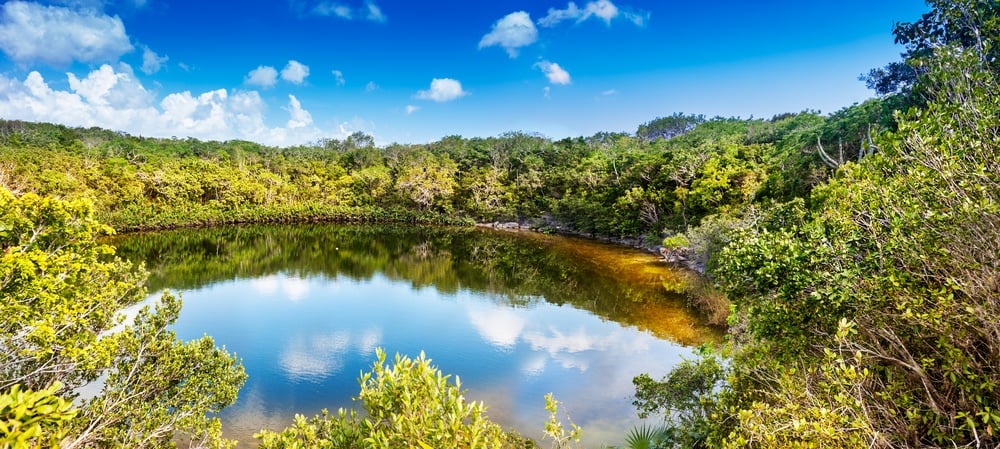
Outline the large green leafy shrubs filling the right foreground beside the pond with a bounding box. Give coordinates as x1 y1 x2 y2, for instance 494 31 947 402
715 31 1000 447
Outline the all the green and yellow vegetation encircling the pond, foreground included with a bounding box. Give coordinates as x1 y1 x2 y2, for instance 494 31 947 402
0 0 1000 448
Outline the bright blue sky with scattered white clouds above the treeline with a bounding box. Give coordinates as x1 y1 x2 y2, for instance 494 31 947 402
0 0 928 146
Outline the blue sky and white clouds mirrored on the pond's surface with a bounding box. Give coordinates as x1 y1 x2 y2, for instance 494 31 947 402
164 273 690 447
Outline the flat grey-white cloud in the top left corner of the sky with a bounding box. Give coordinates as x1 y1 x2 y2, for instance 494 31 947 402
0 1 133 65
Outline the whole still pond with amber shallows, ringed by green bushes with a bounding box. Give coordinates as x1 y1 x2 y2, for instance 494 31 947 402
113 224 720 448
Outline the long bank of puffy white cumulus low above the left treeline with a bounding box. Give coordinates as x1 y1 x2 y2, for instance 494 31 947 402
0 64 364 146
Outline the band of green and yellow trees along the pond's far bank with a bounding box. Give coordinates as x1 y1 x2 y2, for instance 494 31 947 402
0 108 826 240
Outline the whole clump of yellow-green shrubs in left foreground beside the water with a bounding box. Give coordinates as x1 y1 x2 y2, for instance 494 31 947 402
0 191 245 448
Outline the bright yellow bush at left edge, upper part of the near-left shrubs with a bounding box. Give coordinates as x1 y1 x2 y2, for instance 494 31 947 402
0 190 130 391
